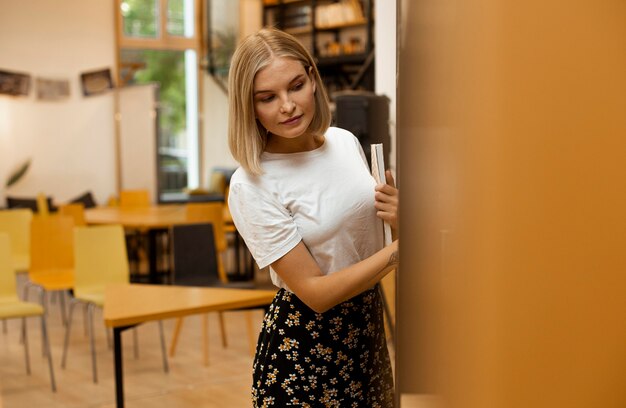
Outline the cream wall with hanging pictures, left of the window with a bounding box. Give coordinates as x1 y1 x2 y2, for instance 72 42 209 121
0 0 115 205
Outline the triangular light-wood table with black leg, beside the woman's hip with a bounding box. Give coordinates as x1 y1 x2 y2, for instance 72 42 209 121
103 284 276 408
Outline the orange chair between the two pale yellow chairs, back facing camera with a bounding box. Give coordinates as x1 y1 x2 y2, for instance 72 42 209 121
23 214 74 324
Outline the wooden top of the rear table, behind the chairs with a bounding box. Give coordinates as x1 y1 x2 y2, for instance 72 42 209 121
85 204 232 228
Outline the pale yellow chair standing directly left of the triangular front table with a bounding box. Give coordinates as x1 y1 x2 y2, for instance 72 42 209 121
61 225 169 383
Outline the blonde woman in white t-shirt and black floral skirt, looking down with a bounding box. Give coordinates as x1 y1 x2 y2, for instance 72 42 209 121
228 29 398 408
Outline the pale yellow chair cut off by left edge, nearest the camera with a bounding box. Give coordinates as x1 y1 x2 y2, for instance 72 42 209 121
0 232 56 392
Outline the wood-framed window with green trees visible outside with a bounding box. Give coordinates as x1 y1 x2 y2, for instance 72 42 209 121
116 0 201 201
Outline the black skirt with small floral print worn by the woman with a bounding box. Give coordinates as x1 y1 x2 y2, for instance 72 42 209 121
252 287 393 408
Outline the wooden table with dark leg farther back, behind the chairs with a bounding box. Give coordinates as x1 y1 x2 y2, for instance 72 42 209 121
85 204 239 283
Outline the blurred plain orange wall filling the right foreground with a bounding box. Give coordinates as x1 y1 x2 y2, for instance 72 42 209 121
397 0 626 408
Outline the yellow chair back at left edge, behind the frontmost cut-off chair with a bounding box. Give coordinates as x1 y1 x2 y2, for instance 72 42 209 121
0 208 33 271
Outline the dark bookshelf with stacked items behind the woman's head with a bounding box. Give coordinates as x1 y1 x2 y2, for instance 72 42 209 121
263 0 375 95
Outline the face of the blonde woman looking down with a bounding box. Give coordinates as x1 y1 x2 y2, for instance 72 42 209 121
253 57 315 143
